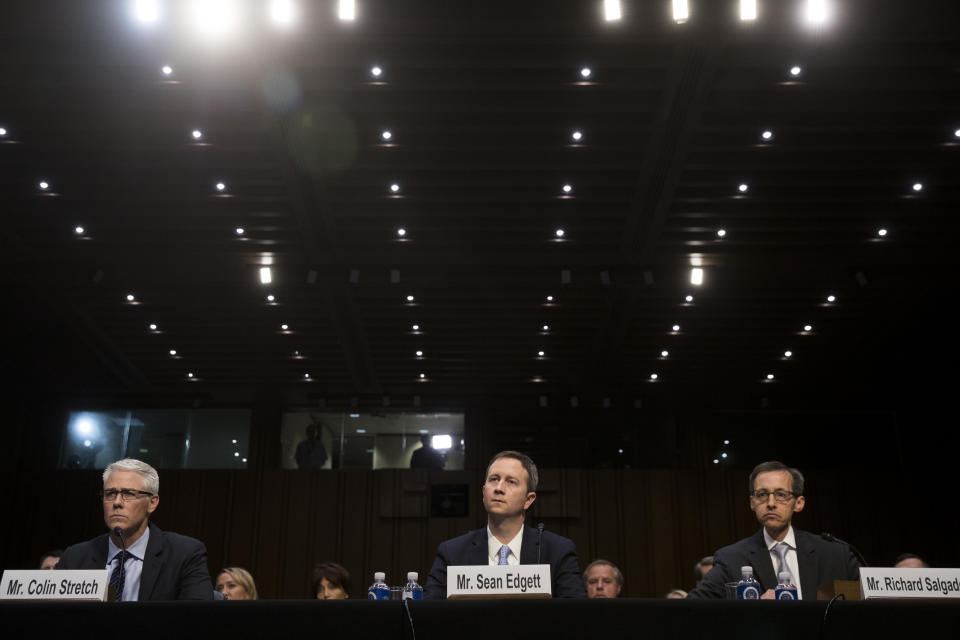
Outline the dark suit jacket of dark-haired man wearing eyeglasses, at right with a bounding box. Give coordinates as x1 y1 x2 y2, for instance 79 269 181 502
687 528 860 600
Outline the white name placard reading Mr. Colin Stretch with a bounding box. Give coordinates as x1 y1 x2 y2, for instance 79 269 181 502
0 569 109 602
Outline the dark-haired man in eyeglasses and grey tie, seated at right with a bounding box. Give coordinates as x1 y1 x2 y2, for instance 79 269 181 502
687 461 860 600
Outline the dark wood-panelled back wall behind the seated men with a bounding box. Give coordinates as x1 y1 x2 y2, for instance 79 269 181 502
0 390 960 598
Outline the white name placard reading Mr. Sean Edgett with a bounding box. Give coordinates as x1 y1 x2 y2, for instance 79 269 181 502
447 564 551 600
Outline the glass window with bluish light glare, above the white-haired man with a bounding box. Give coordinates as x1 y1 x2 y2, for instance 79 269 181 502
60 409 250 469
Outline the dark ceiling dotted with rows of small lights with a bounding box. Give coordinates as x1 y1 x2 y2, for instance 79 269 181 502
0 0 960 408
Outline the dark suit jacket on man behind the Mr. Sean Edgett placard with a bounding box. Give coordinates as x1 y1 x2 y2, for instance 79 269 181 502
423 527 587 600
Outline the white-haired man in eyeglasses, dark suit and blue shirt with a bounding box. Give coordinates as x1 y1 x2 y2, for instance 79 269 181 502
57 458 213 602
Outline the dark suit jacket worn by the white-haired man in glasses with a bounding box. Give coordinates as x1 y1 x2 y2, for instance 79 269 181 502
57 522 213 602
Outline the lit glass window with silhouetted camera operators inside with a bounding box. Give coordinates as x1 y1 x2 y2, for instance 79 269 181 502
280 411 464 469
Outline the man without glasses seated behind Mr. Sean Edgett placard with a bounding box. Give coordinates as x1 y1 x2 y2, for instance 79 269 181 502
423 451 587 599
